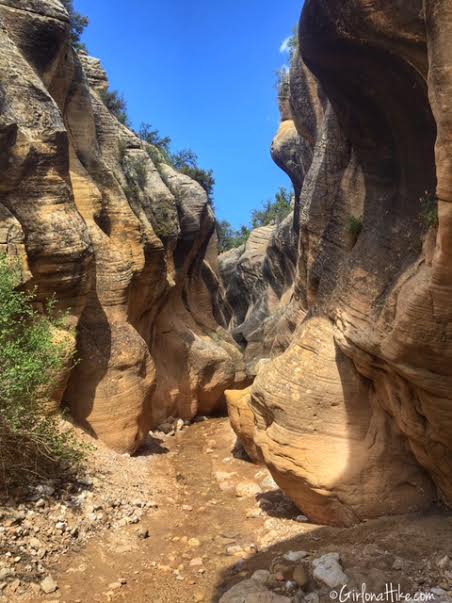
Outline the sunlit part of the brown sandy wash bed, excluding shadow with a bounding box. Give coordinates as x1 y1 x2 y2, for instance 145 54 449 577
39 418 306 603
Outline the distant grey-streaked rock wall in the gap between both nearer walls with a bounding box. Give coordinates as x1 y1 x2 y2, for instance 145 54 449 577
219 217 297 378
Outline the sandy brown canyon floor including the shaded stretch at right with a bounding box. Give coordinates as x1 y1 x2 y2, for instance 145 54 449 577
4 418 452 603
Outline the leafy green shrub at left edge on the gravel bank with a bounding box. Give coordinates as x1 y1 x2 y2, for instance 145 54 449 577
0 255 83 490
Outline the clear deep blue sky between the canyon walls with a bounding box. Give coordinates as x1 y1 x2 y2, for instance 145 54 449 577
74 0 302 227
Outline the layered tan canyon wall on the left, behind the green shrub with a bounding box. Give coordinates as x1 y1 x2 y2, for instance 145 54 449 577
0 0 244 451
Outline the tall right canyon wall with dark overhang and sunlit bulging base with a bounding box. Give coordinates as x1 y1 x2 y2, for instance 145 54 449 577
230 0 452 525
